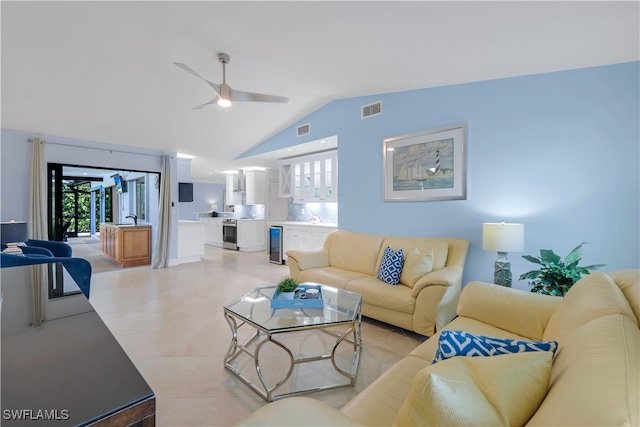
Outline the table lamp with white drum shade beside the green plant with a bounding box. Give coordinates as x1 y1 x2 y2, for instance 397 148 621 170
482 221 524 287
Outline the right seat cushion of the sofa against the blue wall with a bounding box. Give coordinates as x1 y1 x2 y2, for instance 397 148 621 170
345 276 416 314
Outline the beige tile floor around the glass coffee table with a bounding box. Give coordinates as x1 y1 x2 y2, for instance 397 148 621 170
90 246 422 426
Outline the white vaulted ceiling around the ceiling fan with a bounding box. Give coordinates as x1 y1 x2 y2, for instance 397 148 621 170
0 1 640 181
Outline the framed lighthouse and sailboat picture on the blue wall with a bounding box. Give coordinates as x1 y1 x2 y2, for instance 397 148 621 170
383 124 467 202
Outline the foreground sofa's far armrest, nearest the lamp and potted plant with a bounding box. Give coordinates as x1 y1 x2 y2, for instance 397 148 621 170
457 282 562 340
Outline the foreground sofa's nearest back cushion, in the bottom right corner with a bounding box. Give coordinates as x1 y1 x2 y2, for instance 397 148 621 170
529 312 640 426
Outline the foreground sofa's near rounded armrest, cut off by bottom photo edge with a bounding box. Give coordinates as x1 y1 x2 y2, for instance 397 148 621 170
237 397 362 426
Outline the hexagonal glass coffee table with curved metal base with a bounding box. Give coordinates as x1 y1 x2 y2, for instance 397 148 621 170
224 285 362 402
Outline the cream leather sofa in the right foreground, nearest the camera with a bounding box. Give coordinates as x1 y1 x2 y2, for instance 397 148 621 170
241 270 640 426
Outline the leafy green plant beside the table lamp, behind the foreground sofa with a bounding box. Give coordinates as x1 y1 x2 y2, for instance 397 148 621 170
520 242 604 297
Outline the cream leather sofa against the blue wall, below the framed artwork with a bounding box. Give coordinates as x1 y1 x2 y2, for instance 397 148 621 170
287 230 469 336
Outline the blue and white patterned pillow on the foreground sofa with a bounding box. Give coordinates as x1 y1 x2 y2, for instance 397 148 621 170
433 330 558 363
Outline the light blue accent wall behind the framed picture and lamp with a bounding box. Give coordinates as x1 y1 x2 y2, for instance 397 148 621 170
243 62 640 289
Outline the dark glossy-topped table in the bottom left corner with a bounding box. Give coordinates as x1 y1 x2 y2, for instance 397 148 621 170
0 266 156 427
